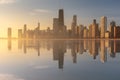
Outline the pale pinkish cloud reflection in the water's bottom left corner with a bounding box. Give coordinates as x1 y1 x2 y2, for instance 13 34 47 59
0 74 24 80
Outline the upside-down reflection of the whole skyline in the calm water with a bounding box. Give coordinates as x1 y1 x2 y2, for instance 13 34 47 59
8 39 120 69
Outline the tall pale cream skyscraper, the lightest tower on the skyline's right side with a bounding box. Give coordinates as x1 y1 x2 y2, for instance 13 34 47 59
100 16 107 38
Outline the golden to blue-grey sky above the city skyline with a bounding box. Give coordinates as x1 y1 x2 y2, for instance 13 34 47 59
0 0 120 37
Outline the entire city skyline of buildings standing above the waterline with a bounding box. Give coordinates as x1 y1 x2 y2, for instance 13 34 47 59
8 9 120 39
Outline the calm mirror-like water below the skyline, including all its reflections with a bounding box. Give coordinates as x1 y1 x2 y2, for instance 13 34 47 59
0 40 120 80
